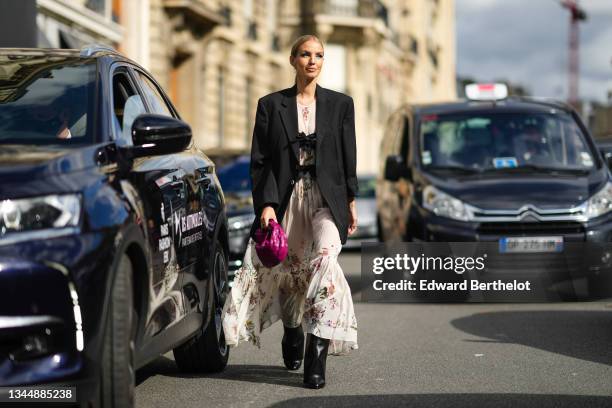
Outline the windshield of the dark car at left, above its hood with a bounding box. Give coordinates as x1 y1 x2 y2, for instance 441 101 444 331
0 55 96 145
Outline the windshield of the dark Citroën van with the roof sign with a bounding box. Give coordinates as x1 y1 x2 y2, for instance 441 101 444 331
420 112 594 174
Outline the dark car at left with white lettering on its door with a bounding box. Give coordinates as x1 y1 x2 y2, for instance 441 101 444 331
0 47 229 407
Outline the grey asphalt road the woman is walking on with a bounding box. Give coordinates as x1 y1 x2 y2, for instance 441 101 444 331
136 253 612 408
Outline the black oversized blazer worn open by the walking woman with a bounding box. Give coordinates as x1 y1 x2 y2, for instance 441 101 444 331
251 85 358 244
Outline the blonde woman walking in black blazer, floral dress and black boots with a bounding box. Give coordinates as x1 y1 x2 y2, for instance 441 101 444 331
223 35 358 388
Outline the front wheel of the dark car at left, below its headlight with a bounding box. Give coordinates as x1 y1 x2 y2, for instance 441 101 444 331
100 254 136 408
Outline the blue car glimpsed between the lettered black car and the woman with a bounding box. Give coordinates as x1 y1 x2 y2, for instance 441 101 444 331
207 149 255 277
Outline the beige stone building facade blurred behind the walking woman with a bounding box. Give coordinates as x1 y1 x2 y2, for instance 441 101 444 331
0 0 456 173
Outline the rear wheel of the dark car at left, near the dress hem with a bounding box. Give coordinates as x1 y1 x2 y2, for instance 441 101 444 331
174 241 229 373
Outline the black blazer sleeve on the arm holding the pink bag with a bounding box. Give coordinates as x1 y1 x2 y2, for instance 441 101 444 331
250 99 279 214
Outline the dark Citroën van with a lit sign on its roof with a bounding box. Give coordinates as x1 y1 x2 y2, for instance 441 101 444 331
376 84 612 294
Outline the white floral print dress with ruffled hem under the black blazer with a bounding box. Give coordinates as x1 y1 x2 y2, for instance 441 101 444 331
222 101 357 354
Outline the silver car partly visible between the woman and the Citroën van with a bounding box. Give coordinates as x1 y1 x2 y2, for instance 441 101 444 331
344 175 378 249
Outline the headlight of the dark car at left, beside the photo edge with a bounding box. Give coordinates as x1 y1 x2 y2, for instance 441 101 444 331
0 194 81 237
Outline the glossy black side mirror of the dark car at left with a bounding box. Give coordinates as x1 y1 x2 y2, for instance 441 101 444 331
131 113 191 157
